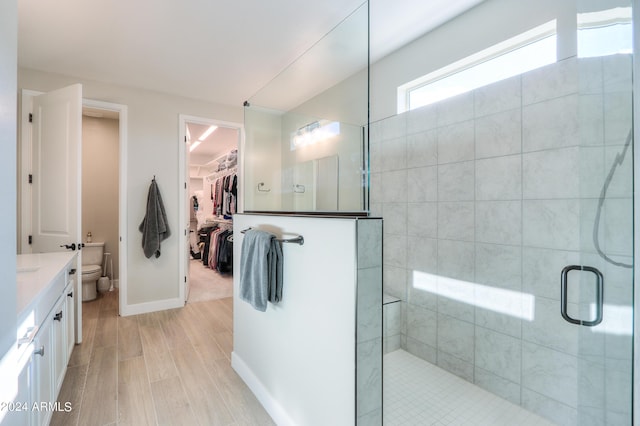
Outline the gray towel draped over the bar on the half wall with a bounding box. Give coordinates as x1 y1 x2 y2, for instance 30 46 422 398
240 229 282 312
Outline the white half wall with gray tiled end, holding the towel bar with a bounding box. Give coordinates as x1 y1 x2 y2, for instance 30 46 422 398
232 215 382 425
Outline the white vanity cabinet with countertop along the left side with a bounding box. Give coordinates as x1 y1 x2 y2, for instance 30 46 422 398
1 252 76 426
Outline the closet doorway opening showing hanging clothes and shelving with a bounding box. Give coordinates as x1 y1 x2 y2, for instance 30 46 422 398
180 116 241 303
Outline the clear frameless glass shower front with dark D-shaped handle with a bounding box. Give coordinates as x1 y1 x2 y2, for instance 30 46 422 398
378 0 634 426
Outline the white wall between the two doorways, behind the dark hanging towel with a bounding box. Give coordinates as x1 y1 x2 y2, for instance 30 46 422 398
18 69 242 310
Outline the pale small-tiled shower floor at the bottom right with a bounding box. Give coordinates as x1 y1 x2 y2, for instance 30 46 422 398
383 349 553 426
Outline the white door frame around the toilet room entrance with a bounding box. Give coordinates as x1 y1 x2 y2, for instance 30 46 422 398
17 89 128 320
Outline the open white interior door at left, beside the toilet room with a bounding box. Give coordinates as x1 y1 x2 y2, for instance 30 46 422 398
32 84 82 342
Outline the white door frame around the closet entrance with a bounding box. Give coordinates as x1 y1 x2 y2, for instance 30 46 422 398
178 114 244 304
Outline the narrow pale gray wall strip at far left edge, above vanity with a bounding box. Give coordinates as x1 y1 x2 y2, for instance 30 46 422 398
0 0 18 359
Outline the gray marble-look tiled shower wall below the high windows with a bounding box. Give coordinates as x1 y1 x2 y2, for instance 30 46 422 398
370 55 633 424
